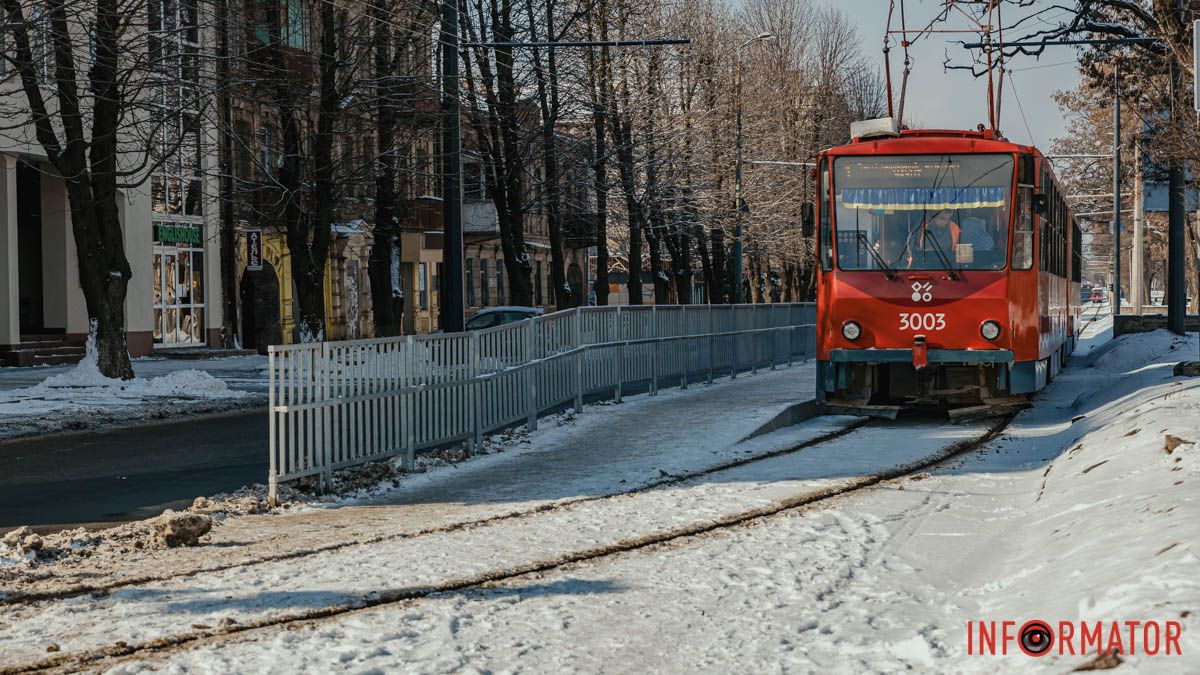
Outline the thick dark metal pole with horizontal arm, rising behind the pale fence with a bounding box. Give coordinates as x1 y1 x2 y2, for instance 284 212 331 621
439 0 466 333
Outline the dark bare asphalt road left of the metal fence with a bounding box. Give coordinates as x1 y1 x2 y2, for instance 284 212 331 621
0 408 268 532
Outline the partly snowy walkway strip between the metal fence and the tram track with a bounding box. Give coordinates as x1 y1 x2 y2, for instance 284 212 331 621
0 365 825 592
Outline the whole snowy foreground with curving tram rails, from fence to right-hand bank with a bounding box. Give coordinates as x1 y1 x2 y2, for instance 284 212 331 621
0 321 1200 673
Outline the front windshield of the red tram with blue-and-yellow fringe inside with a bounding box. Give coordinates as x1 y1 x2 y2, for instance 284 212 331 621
833 155 1013 270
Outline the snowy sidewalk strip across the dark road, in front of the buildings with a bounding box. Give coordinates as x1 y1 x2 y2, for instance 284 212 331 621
0 338 266 438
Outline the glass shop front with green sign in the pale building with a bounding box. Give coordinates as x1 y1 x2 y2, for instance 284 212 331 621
151 222 205 347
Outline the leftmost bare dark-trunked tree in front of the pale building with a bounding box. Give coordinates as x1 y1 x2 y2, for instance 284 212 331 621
0 0 200 378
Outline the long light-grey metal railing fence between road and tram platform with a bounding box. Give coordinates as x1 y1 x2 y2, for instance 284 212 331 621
269 299 815 501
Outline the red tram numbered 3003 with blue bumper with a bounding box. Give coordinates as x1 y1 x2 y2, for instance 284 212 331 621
815 119 1080 414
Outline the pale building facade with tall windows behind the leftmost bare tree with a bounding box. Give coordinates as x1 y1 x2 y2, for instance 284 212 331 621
0 0 222 365
